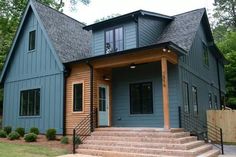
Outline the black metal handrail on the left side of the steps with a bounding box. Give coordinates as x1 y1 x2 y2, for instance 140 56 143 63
73 108 98 153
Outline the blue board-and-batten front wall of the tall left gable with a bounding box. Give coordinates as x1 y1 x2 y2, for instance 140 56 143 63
3 10 64 134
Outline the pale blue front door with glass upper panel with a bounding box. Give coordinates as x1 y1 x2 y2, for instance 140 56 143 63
99 85 109 126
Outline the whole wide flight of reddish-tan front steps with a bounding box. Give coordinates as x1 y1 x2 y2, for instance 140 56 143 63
76 127 220 157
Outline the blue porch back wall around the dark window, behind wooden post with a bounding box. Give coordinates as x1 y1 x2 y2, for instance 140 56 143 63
112 62 178 127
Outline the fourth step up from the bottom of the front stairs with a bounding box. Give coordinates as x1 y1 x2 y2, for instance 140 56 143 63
87 135 197 143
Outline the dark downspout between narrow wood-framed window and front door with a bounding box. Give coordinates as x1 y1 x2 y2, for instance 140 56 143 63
87 61 93 132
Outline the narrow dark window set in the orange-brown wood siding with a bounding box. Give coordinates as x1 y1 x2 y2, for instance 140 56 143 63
73 83 83 112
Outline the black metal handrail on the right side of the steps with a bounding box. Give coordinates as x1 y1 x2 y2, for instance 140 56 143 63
178 106 224 154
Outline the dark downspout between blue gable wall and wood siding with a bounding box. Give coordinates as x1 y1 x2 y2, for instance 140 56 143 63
63 68 70 136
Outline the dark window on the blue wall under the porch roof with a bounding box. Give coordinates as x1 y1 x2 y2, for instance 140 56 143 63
130 82 153 114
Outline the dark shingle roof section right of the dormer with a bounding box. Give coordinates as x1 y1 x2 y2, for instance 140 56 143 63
157 9 205 52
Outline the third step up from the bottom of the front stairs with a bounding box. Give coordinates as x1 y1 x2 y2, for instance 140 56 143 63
84 140 204 150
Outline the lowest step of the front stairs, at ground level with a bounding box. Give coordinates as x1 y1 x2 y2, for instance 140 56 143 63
77 149 178 157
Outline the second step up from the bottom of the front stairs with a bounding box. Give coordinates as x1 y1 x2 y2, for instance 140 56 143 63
78 144 201 157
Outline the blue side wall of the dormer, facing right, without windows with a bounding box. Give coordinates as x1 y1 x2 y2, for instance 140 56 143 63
138 16 167 47
